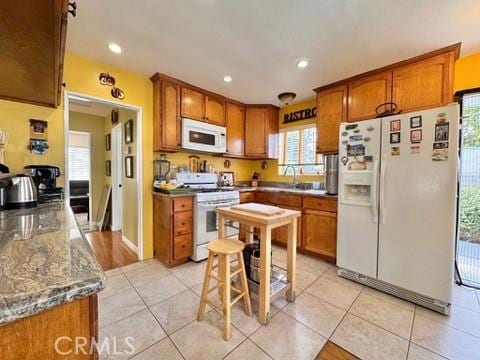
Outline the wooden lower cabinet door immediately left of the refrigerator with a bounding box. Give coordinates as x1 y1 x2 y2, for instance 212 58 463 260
302 210 337 259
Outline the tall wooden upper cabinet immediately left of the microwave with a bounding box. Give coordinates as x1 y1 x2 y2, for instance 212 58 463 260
153 80 181 151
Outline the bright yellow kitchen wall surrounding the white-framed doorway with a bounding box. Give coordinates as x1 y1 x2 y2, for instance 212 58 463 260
0 53 153 258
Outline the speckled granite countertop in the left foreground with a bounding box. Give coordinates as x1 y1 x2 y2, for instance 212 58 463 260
0 203 106 324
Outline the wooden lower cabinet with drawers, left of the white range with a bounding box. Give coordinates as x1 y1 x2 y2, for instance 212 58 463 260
153 195 193 266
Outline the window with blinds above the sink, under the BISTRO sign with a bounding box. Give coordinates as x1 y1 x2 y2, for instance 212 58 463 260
278 125 324 175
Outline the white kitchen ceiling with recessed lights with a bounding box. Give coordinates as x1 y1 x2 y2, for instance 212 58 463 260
67 0 480 104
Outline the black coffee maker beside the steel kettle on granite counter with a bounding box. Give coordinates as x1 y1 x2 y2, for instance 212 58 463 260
24 165 63 203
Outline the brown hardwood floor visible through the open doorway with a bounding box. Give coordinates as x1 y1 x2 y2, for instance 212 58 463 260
86 231 138 271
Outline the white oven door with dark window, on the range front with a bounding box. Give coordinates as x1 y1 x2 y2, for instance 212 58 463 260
195 200 239 246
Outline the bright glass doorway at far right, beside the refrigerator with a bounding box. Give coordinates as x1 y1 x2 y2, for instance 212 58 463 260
457 89 480 288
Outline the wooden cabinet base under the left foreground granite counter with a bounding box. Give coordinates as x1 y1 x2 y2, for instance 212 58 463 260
0 294 98 360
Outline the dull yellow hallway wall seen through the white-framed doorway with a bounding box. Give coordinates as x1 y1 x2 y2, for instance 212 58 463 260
68 111 105 219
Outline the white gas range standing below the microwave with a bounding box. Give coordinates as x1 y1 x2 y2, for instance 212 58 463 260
176 173 240 261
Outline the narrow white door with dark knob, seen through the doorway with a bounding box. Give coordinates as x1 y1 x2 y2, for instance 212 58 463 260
111 124 123 231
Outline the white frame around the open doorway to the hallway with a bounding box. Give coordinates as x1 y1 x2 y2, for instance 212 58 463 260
63 90 144 261
